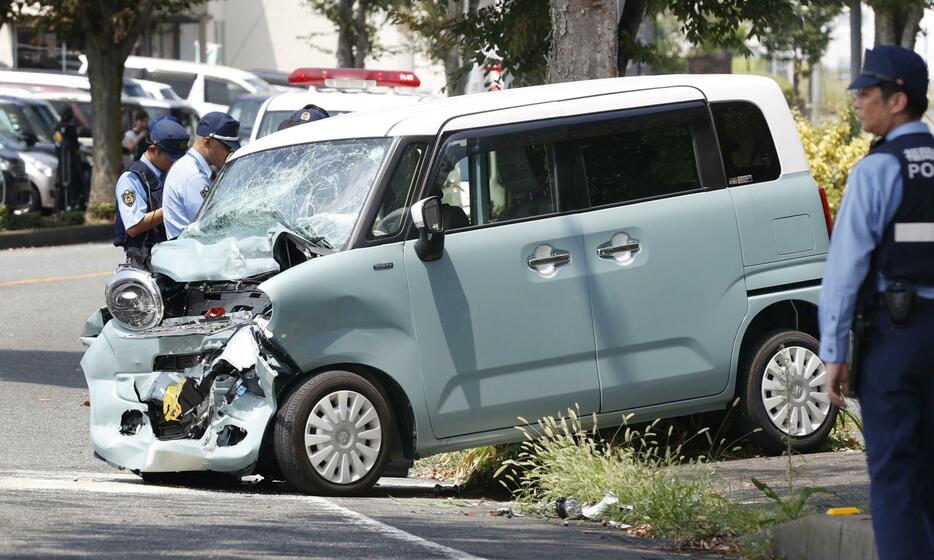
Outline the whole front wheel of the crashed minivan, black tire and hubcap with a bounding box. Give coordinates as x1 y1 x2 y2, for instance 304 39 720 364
273 371 393 496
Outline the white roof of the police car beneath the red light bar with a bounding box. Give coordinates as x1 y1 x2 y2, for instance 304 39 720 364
265 88 431 113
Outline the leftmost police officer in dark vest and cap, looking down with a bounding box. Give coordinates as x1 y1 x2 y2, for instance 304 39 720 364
114 117 190 267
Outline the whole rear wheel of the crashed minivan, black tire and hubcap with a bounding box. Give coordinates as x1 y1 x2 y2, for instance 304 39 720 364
737 330 837 453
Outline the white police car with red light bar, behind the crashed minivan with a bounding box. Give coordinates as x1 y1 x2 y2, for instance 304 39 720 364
249 68 434 141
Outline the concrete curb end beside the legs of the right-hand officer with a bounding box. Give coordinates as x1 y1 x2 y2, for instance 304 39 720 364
771 515 879 560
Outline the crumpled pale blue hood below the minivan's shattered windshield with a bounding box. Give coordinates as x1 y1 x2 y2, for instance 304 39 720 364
151 235 279 282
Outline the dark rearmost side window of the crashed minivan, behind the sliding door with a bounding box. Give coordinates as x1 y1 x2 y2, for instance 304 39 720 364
710 101 781 186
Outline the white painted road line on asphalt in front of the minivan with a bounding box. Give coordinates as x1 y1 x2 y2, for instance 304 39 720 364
0 471 479 560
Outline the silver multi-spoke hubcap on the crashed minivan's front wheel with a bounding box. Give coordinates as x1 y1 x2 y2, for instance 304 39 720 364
305 391 382 484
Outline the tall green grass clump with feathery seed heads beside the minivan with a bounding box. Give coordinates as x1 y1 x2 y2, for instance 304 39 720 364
500 409 757 541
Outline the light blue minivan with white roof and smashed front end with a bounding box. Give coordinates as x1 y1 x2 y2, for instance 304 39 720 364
81 76 836 495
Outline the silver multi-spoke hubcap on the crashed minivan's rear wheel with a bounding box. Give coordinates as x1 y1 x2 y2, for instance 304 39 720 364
762 346 830 437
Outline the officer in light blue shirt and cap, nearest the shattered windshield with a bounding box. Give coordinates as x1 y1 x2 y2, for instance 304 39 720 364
163 111 240 239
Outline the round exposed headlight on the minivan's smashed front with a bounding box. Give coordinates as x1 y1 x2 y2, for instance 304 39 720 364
104 267 163 330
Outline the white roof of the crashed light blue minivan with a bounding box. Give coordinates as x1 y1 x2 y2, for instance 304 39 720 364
239 74 808 173
